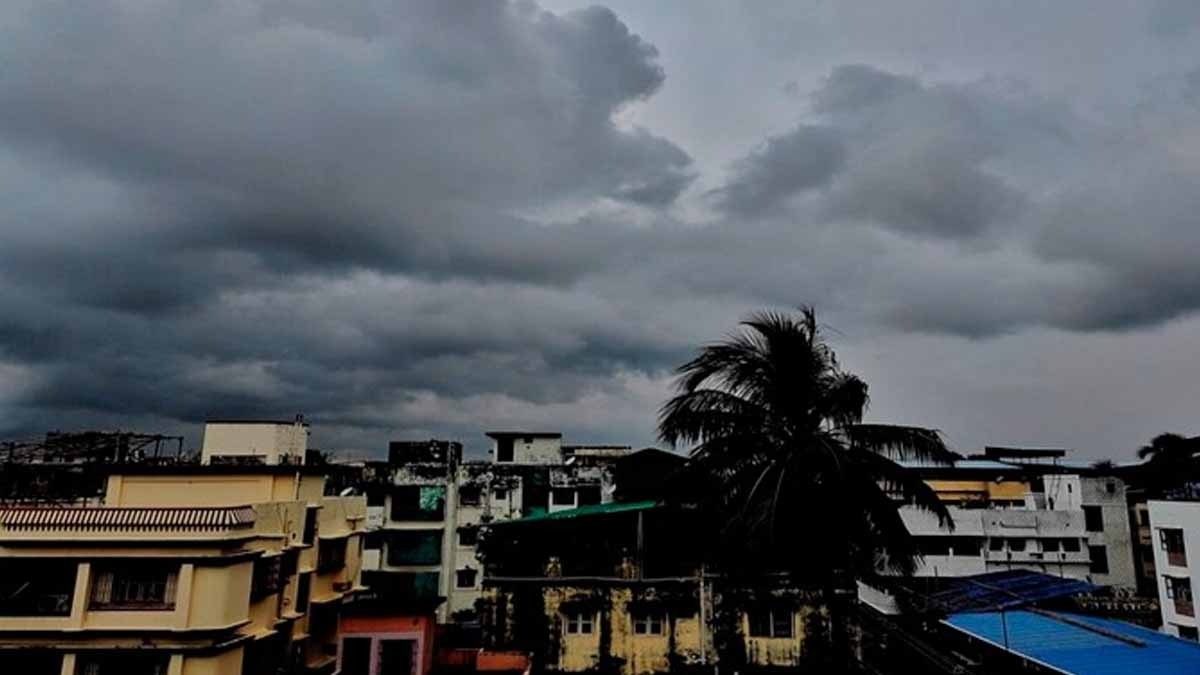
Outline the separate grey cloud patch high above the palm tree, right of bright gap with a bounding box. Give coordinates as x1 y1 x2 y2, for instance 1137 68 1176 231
714 65 1030 238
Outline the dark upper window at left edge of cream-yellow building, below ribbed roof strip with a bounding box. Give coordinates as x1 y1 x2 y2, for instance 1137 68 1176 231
0 558 78 614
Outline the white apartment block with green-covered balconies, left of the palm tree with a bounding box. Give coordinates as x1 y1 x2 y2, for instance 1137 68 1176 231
364 431 630 623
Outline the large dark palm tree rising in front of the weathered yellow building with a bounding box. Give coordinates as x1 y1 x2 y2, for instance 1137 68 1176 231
659 307 956 662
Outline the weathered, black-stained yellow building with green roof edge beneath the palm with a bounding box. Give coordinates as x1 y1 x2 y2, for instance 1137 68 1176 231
480 502 824 675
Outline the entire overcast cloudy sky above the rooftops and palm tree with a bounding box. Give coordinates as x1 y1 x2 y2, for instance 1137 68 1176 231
0 0 1200 458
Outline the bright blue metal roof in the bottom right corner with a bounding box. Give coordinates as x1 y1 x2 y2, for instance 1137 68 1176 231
943 610 1200 675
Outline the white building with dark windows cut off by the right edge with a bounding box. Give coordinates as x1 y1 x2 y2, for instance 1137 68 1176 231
1150 501 1200 640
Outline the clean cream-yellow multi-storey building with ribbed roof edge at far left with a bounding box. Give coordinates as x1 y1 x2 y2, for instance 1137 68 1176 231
0 465 366 675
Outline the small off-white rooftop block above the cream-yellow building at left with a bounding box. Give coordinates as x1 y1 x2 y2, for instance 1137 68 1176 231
200 416 308 465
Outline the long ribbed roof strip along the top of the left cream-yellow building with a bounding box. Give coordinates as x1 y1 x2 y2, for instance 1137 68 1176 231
0 506 254 530
